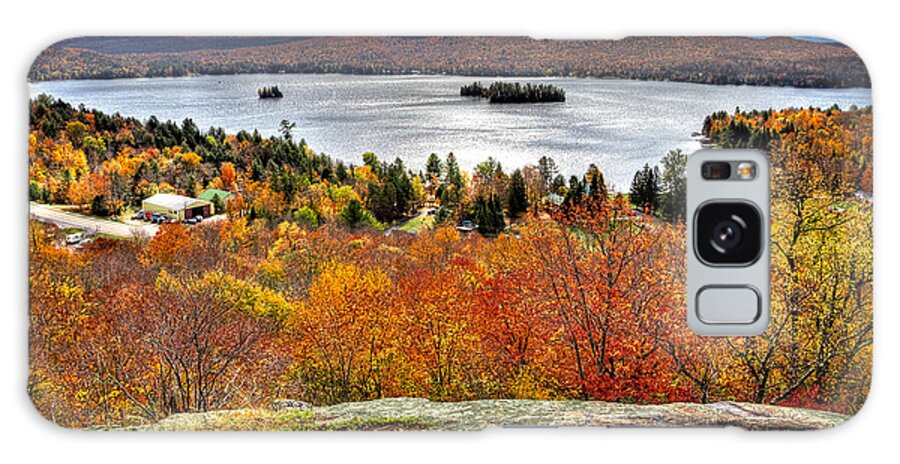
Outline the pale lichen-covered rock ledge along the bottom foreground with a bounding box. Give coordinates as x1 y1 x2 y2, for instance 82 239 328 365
137 398 848 430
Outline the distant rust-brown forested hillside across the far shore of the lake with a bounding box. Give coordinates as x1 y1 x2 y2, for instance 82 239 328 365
29 37 870 87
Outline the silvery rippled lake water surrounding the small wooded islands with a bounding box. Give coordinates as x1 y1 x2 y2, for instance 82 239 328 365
28 74 872 190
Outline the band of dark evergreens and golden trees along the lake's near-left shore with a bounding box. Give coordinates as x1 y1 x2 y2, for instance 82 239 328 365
29 95 576 230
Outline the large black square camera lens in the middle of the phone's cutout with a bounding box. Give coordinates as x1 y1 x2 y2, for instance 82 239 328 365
694 202 762 266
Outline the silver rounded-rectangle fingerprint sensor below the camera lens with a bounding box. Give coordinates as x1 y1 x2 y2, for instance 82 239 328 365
697 285 762 324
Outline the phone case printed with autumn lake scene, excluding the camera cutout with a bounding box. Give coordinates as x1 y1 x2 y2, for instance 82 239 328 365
27 37 873 430
